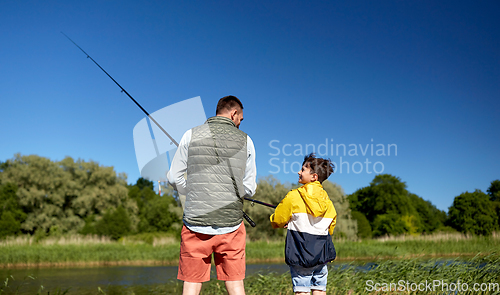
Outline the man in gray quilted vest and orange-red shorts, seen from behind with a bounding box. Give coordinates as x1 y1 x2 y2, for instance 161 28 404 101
168 96 257 295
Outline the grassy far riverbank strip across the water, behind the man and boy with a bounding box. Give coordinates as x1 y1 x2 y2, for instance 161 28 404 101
0 234 500 268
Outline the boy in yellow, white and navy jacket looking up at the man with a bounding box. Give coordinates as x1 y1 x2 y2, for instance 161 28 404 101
270 154 337 295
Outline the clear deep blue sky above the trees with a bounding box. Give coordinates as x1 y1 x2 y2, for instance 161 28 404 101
0 0 500 211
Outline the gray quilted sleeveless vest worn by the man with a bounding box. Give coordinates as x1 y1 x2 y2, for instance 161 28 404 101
184 116 247 227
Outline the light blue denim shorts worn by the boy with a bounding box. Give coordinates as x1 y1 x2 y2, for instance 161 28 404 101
290 264 328 292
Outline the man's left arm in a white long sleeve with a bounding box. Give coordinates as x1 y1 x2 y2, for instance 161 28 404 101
167 130 191 195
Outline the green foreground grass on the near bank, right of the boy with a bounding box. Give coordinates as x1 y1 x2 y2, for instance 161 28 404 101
327 256 500 294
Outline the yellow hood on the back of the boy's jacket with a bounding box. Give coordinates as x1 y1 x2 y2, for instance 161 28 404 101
297 181 330 217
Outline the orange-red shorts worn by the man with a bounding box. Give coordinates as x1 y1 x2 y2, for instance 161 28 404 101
177 222 246 283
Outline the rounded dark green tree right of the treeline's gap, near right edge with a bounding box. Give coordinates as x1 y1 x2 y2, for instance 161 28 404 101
448 190 498 236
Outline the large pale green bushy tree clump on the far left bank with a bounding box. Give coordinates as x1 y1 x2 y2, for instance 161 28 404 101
0 154 138 233
